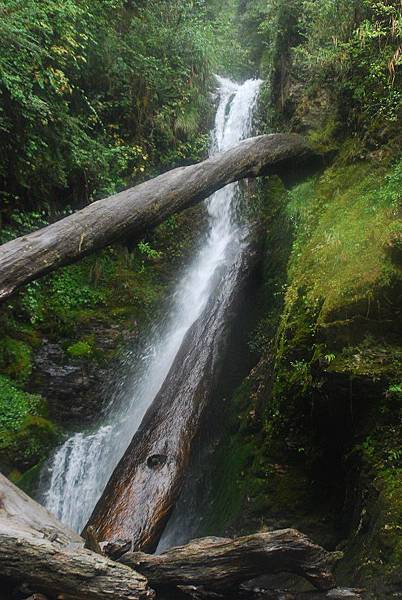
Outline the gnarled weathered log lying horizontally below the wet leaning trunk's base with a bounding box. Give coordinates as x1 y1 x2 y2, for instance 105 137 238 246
120 529 339 593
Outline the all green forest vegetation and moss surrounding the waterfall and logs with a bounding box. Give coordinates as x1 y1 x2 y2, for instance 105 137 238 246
0 0 402 598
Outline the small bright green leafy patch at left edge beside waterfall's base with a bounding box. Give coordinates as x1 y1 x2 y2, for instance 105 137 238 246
0 375 43 431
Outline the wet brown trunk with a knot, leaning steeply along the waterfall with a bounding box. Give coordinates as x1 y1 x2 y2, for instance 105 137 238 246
84 226 258 552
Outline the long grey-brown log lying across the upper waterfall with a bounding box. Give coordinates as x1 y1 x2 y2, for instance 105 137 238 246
0 134 311 299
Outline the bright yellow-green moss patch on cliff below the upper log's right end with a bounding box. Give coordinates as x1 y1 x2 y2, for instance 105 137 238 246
287 161 402 322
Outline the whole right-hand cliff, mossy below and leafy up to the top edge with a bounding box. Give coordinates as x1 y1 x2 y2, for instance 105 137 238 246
206 2 402 598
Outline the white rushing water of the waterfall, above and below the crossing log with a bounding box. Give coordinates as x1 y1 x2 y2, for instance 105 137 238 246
42 77 261 531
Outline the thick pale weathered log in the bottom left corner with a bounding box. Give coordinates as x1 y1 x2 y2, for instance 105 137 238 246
0 474 155 600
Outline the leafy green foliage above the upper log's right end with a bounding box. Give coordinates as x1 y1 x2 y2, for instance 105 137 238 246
251 0 402 142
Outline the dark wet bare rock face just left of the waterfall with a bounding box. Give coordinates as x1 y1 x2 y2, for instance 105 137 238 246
30 323 136 427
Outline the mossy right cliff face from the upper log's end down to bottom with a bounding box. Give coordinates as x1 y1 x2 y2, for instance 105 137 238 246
207 137 402 597
